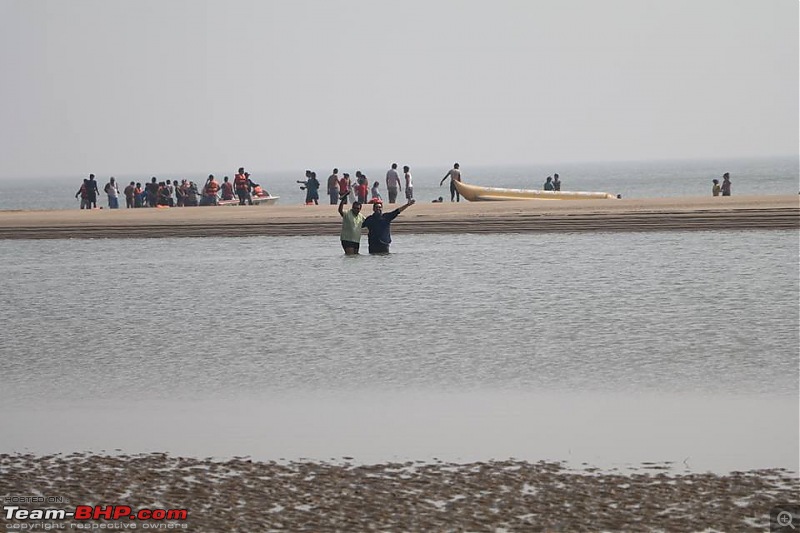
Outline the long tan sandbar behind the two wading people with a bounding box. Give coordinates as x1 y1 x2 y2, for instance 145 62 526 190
0 195 800 239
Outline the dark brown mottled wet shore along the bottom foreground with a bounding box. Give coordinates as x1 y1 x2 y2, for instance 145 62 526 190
0 454 800 532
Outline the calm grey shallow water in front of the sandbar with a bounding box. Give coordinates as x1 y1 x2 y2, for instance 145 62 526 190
0 231 800 471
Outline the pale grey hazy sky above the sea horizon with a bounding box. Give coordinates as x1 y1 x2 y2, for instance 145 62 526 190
0 0 799 178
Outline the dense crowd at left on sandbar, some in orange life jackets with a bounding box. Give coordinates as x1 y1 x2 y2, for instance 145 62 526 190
75 168 269 209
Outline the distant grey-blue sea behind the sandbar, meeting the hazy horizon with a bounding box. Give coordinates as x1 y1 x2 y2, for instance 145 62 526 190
0 156 800 210
